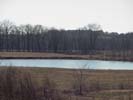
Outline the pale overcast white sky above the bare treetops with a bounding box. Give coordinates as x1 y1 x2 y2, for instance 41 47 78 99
0 0 133 33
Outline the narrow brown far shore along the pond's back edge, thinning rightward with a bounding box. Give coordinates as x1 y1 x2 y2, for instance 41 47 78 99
0 52 133 62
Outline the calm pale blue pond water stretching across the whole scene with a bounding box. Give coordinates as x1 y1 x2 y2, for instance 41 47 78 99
0 59 133 70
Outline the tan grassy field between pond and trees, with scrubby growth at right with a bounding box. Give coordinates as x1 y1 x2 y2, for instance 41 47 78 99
0 51 133 61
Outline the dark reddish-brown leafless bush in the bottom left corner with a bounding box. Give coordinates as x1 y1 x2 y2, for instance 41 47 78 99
0 67 38 100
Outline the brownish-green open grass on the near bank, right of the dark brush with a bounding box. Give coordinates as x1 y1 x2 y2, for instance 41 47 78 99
0 67 133 100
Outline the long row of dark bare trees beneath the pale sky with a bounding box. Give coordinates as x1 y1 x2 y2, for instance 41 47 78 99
0 21 133 54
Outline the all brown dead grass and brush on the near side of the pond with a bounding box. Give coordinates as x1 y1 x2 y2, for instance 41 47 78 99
0 67 133 100
